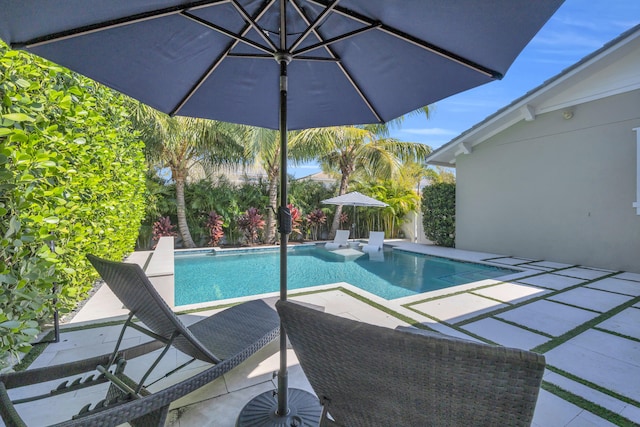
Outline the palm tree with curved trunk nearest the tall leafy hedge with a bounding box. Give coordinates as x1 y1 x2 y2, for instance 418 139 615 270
133 104 243 248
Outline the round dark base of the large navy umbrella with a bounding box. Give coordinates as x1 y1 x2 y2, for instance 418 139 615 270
236 388 322 427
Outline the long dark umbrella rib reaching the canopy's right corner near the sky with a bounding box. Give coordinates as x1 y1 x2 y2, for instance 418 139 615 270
309 0 503 80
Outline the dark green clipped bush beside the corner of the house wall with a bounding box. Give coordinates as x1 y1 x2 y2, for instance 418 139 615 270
422 182 456 248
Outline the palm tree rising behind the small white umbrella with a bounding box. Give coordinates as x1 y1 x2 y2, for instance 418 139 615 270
290 123 431 239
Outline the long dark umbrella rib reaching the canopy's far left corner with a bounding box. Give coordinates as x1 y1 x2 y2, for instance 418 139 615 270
11 0 231 49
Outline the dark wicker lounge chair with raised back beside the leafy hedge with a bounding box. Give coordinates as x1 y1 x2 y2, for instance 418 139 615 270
0 255 279 427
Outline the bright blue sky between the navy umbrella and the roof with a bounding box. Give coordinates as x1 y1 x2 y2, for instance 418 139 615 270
289 0 640 178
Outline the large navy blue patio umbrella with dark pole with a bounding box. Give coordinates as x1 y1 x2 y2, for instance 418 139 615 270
0 0 562 425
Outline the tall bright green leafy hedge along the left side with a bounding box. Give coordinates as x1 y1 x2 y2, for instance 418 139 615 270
0 43 145 363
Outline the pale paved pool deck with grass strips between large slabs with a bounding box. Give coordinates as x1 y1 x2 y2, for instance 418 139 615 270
0 242 640 427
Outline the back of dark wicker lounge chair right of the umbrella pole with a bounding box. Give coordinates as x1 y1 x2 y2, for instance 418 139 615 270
276 302 545 427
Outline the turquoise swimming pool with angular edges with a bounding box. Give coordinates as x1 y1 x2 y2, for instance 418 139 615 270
175 245 516 305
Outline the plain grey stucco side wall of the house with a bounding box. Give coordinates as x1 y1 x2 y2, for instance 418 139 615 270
456 90 640 272
